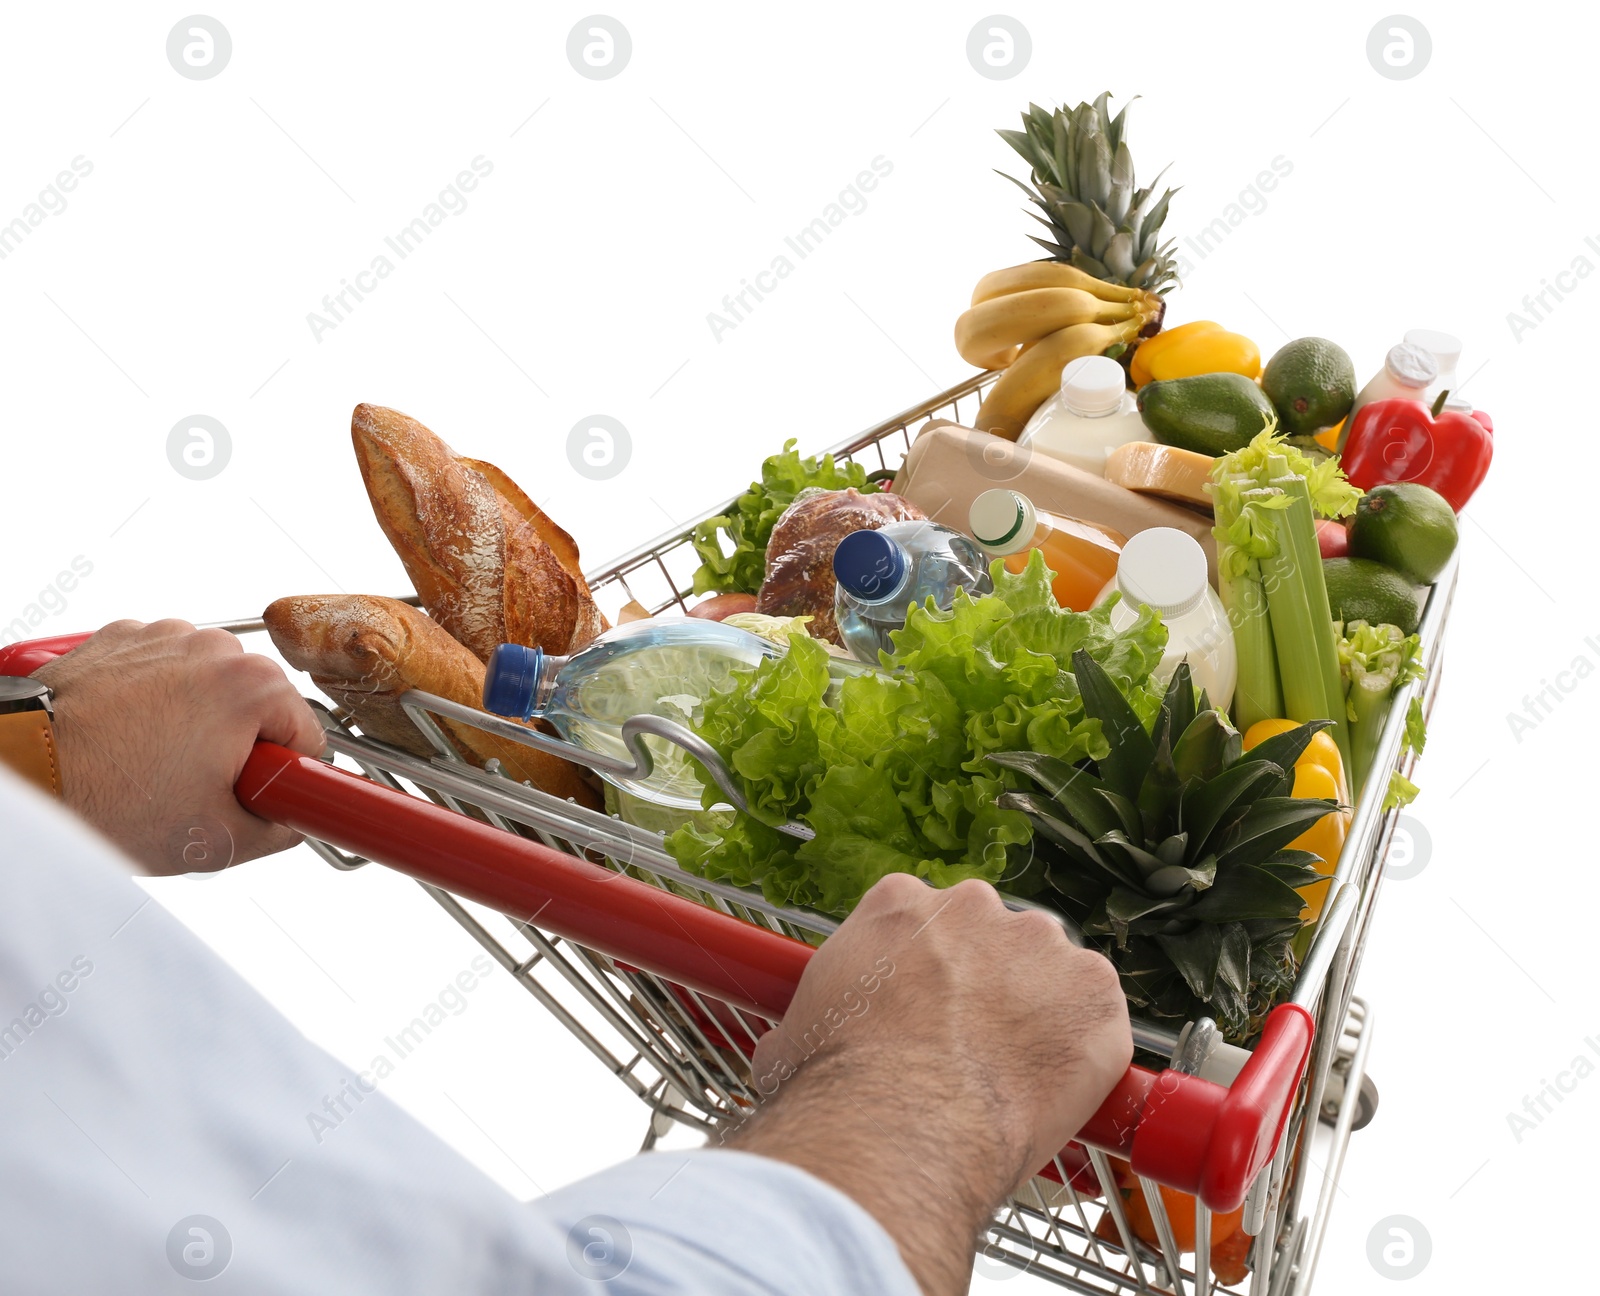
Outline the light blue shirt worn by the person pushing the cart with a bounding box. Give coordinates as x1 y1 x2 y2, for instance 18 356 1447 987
0 771 917 1296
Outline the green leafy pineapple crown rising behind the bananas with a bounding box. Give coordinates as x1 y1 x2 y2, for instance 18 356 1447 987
998 91 1178 293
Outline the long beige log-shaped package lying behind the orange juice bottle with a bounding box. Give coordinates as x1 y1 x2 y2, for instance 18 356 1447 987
893 419 1216 584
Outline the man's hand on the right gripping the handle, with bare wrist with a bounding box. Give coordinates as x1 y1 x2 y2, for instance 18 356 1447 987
730 874 1133 1296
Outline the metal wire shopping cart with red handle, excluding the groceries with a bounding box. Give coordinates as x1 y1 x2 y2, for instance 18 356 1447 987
0 366 1456 1296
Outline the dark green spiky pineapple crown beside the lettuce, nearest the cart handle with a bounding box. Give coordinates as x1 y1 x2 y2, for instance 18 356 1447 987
989 650 1336 1043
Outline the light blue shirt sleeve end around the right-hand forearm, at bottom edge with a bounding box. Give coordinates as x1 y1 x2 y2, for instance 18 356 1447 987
534 1147 920 1296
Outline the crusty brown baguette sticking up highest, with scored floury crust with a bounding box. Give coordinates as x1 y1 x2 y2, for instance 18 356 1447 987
350 405 605 661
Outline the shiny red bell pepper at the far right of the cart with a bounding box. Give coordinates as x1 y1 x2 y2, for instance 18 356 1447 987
1339 395 1494 514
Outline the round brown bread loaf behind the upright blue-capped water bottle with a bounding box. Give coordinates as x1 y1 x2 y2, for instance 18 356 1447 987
755 486 923 646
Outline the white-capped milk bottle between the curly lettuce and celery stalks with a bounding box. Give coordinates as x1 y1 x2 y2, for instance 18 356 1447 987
1101 526 1238 710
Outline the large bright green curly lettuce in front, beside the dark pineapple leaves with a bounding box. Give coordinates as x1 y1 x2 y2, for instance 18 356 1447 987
667 554 1166 912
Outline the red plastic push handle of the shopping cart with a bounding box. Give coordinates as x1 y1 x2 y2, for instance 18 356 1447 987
0 635 1312 1211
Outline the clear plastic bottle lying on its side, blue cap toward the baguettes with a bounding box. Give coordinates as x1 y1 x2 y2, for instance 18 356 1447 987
483 619 784 810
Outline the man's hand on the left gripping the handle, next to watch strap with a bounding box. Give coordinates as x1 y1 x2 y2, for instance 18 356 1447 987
34 621 323 874
